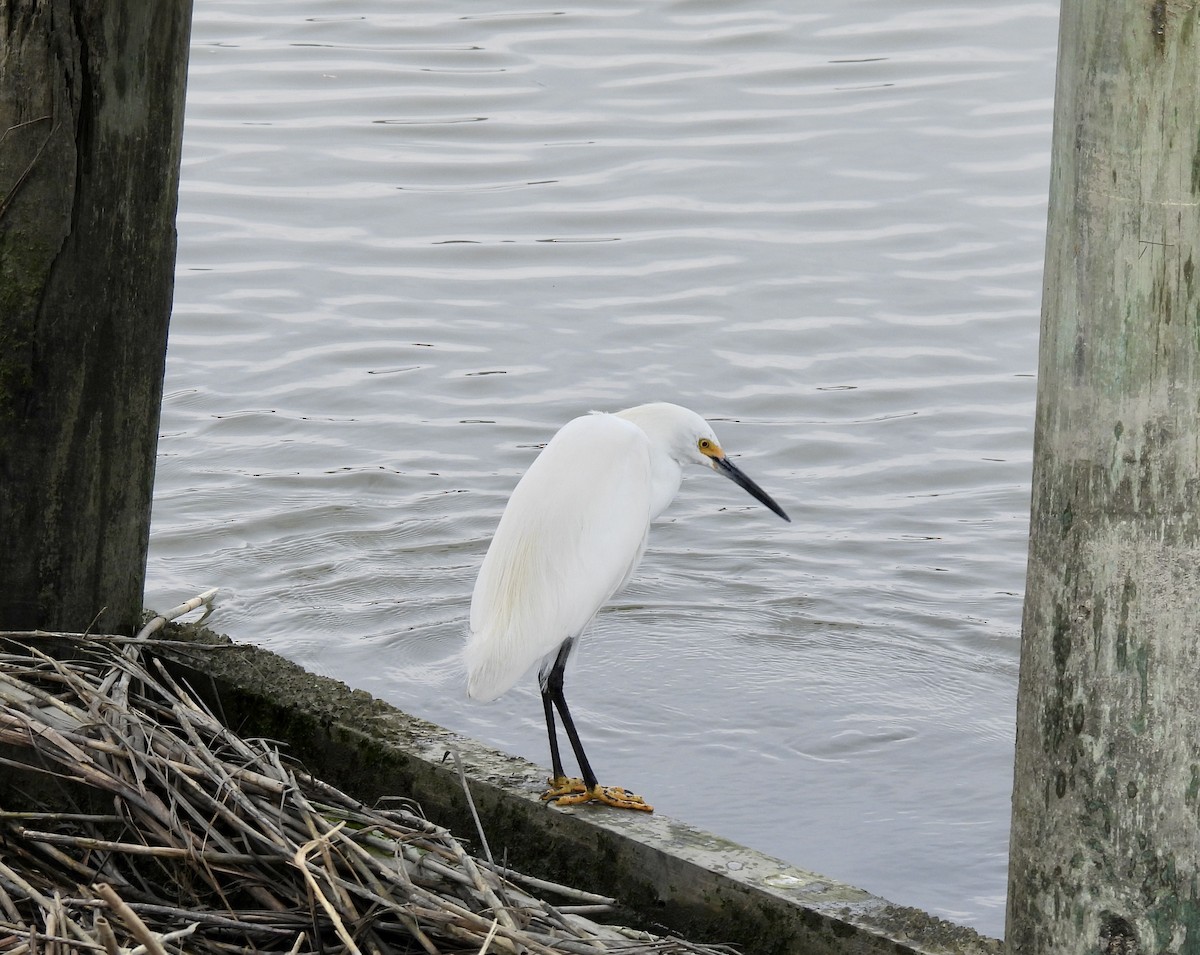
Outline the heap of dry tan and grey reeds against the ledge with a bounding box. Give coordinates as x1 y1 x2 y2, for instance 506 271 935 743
0 599 718 955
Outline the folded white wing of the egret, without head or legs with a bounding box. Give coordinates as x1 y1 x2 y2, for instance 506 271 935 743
466 415 650 699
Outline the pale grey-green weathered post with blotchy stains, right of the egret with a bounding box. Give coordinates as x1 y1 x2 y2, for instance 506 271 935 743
1006 0 1200 955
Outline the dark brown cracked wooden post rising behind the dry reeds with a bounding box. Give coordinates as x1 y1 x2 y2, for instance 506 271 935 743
0 0 191 632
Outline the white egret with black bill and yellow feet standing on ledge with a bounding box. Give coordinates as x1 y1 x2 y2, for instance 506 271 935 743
466 402 791 811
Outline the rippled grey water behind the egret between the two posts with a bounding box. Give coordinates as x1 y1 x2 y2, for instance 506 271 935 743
148 0 1057 935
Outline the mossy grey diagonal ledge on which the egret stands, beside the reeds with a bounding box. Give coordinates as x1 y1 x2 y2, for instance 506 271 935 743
158 626 1001 955
